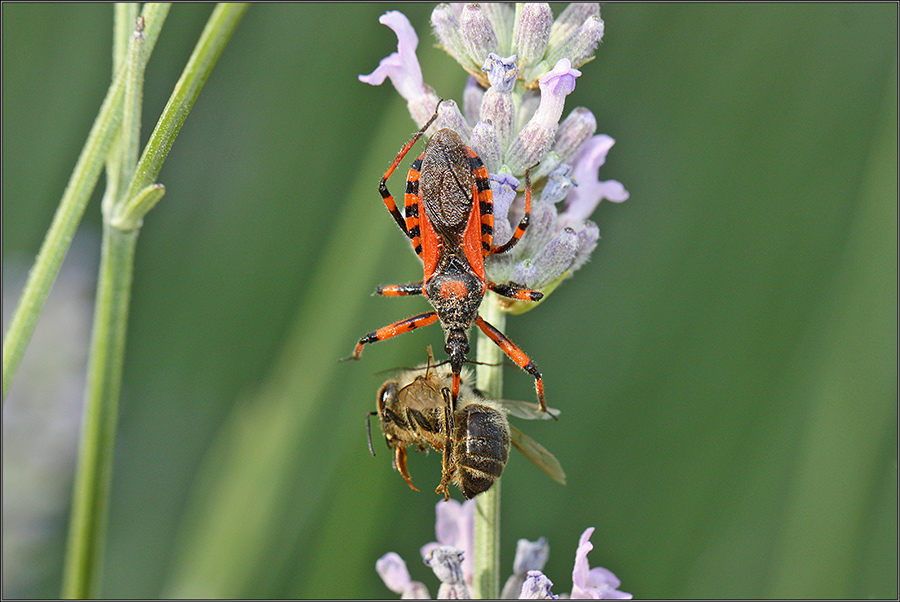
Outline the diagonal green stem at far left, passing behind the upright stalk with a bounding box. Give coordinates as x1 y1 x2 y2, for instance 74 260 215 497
3 4 169 400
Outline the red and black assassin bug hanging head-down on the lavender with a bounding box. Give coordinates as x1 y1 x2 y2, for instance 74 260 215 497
346 101 547 411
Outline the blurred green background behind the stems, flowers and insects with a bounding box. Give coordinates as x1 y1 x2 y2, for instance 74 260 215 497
2 3 898 598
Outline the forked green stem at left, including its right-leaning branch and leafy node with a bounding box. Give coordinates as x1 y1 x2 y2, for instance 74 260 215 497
61 4 247 598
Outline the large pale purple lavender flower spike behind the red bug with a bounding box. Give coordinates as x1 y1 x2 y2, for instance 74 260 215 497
360 3 628 310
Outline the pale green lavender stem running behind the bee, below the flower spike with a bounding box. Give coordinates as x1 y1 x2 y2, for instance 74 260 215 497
472 292 506 599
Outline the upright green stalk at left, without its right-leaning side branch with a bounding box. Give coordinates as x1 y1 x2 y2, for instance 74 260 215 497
62 9 146 598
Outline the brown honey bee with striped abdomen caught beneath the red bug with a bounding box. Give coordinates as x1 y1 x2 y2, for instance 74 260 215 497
369 348 566 500
